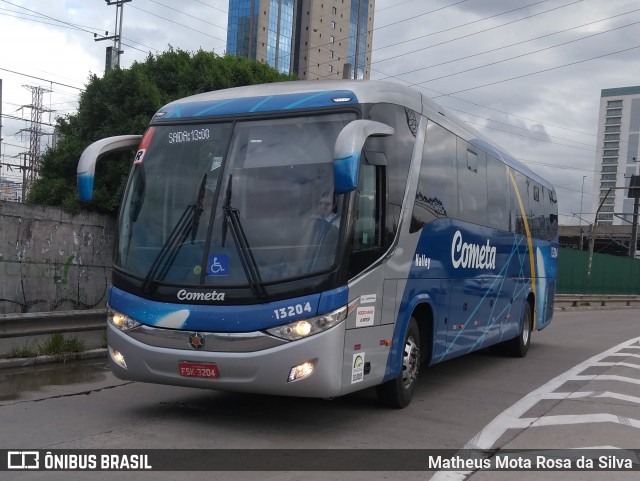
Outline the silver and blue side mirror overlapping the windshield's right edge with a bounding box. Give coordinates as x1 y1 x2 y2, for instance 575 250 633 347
333 120 395 194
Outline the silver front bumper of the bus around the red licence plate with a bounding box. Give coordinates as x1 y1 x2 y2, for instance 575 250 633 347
107 322 345 398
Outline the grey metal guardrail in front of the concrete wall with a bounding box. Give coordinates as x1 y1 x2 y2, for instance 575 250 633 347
0 309 107 339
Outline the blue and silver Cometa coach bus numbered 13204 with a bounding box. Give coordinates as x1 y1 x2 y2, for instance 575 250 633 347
78 80 558 407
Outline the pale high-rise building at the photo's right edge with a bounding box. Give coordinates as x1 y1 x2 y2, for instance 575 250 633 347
593 86 640 225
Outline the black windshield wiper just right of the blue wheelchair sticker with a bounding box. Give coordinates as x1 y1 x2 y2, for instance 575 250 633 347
222 174 267 297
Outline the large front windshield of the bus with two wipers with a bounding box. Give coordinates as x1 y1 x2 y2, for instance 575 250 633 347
115 113 356 288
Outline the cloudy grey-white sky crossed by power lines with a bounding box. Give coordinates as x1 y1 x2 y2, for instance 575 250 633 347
0 0 640 224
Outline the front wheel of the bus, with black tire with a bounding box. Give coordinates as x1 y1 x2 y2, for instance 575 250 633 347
376 317 421 409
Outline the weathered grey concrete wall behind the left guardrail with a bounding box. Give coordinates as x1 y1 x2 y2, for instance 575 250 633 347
0 201 115 314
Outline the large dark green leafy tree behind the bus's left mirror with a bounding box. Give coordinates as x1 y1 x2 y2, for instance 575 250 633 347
26 48 294 214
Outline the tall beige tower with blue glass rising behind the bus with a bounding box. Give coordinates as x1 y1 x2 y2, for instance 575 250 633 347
227 0 375 80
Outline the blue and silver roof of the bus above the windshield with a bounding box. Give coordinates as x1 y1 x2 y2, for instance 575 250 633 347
154 80 553 190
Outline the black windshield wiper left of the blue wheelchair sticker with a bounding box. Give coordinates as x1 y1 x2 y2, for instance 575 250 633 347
142 174 207 292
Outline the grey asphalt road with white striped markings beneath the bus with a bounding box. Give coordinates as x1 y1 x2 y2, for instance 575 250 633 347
0 309 640 481
